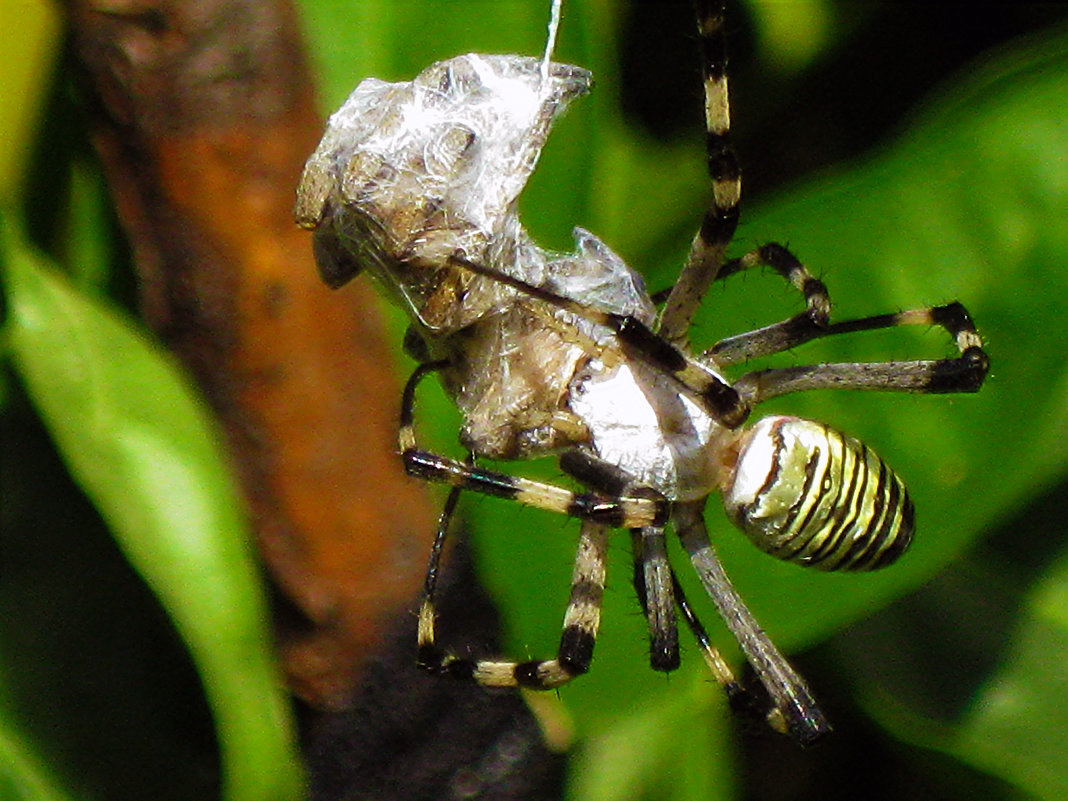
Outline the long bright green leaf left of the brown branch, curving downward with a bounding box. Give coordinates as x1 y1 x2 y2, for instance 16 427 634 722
0 220 301 801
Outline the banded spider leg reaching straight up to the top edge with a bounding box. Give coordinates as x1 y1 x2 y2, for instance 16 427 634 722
660 0 741 343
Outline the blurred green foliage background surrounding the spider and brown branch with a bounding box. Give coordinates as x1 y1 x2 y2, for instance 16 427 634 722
0 0 1068 799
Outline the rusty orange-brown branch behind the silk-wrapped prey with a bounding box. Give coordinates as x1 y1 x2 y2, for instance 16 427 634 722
63 0 434 707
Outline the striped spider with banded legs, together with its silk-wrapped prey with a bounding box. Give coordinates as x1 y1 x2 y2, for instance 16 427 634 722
295 0 988 744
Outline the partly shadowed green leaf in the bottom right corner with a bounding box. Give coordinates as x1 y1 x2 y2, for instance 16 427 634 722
835 540 1068 801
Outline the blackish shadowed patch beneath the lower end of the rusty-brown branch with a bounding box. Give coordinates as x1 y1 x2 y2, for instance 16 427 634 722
302 543 565 801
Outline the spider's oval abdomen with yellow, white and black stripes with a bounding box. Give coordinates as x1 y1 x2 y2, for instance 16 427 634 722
723 417 913 570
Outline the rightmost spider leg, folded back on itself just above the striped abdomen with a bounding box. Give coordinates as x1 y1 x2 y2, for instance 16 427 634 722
726 302 990 405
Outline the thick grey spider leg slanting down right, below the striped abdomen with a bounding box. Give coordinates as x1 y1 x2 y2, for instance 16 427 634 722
675 501 831 745
